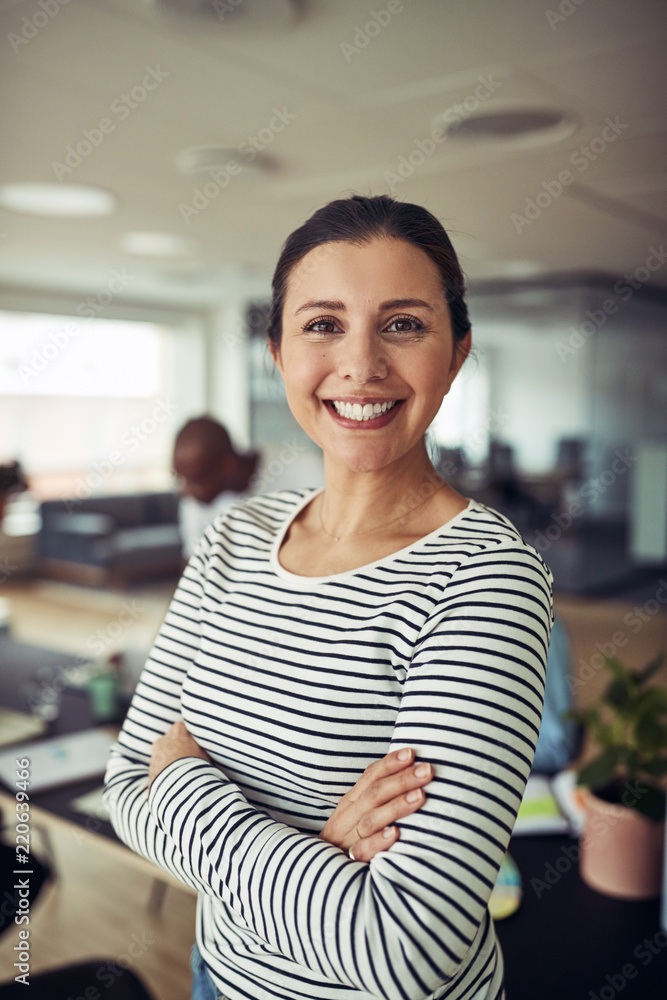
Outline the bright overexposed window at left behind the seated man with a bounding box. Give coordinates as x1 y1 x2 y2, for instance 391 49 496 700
0 311 204 499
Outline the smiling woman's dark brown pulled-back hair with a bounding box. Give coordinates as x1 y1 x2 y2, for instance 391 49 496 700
267 194 470 350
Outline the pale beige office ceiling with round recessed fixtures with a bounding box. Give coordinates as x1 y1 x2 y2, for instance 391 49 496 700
0 0 667 306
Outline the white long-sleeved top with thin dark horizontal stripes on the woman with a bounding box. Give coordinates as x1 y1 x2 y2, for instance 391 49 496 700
105 491 552 1000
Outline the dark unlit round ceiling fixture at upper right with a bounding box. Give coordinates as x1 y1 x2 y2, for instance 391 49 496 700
434 104 578 146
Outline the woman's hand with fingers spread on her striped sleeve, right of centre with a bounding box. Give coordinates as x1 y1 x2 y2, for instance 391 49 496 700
319 748 433 861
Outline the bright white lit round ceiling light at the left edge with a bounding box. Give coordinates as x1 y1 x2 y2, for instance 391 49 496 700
0 183 116 218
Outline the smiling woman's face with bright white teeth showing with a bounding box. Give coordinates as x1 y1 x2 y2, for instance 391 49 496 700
274 238 469 472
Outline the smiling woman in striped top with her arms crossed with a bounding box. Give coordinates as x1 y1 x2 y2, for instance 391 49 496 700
107 189 551 1000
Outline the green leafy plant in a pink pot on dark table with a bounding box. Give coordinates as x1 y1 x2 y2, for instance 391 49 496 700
568 655 667 899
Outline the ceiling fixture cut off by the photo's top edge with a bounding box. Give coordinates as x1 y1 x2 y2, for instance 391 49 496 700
147 0 299 29
